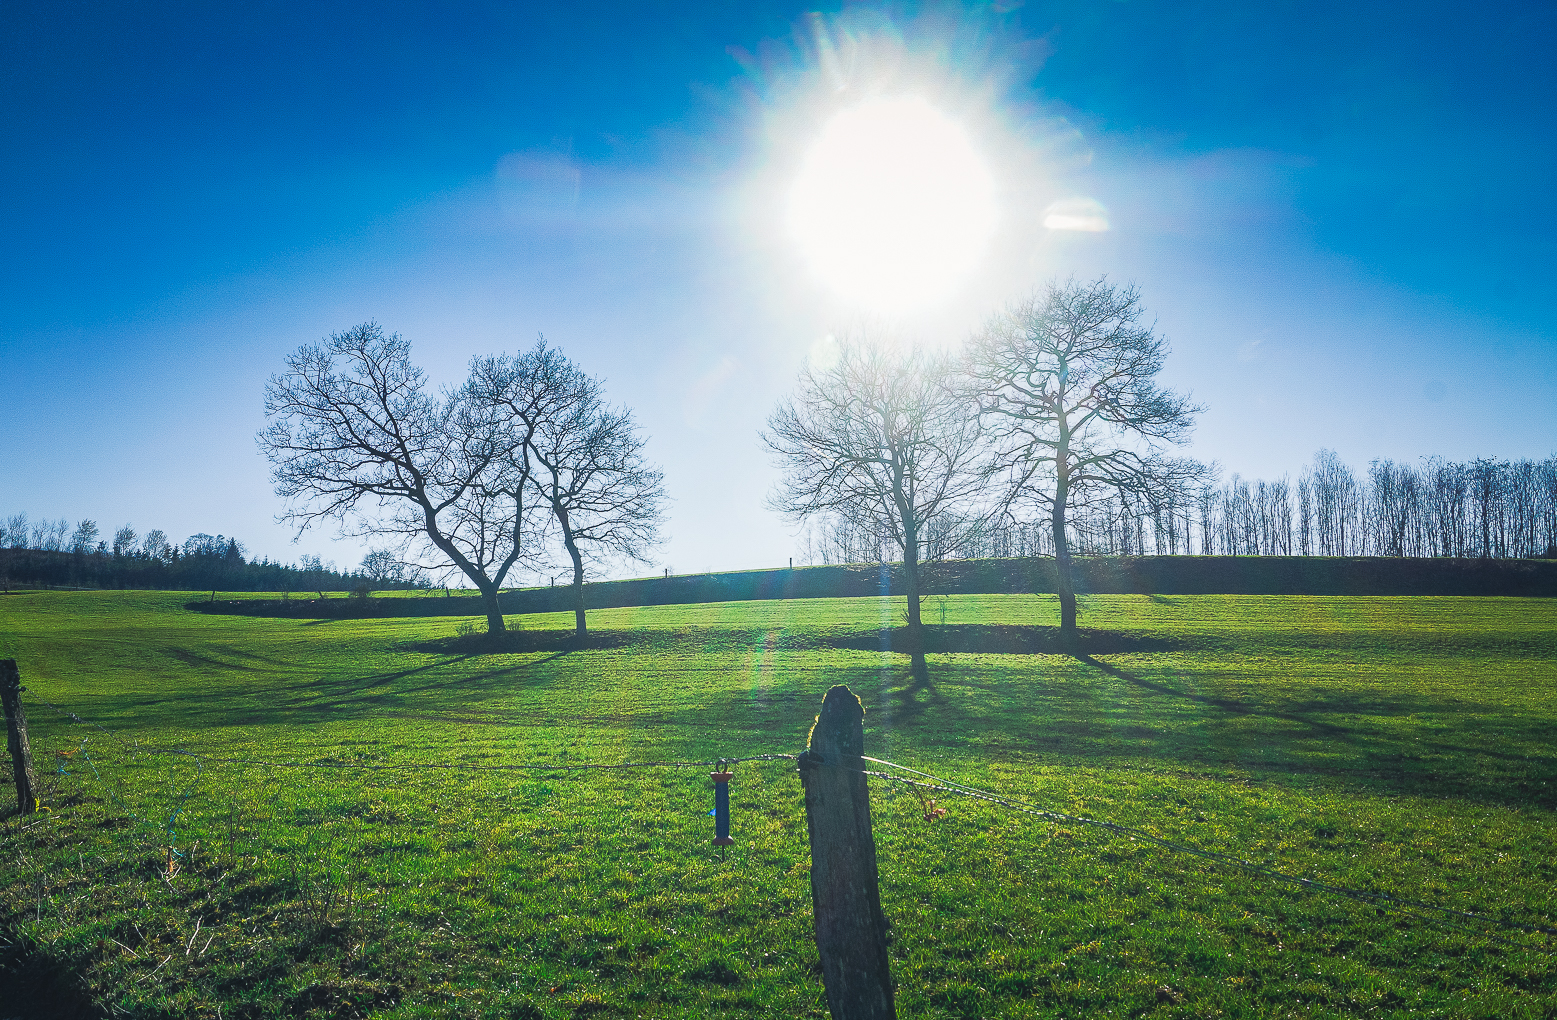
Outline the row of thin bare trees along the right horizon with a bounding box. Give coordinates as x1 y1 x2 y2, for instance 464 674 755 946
800 450 1557 564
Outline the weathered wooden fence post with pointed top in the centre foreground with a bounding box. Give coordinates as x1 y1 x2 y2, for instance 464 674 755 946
800 684 897 1020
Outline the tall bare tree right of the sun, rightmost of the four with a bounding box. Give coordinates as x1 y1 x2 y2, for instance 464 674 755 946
967 279 1205 640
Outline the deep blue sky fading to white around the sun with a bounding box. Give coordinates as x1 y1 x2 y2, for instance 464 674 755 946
0 0 1557 572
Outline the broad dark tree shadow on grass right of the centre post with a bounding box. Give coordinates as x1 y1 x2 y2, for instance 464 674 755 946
744 654 1557 810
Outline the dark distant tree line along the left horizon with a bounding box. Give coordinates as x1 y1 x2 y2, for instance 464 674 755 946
0 512 427 595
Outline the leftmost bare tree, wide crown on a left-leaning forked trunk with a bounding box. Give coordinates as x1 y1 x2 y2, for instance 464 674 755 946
258 322 535 632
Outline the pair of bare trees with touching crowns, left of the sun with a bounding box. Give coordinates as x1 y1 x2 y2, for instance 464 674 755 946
258 322 665 638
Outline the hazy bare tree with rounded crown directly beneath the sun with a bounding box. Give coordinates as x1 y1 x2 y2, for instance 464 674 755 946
763 341 981 684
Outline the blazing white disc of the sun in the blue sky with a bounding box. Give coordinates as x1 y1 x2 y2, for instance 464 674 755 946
788 98 995 313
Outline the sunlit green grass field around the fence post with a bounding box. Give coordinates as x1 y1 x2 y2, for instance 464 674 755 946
0 592 1557 1020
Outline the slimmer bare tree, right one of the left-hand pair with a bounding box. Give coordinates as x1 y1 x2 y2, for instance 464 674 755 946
470 345 665 643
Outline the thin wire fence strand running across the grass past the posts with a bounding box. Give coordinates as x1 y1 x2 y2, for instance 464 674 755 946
12 698 1557 942
